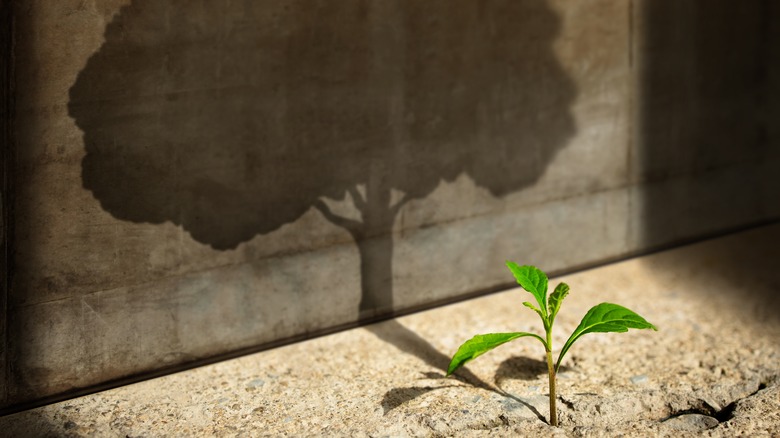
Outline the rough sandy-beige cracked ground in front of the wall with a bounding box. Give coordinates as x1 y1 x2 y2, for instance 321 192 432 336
0 225 780 437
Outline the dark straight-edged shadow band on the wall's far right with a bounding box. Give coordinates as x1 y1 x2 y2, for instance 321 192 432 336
638 0 780 247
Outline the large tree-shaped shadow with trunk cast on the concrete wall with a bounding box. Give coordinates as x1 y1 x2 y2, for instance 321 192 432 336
68 0 575 317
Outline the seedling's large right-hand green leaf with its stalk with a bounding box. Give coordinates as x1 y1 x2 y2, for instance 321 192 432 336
555 303 658 372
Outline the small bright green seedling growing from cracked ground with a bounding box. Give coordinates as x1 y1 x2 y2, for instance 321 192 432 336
447 262 658 426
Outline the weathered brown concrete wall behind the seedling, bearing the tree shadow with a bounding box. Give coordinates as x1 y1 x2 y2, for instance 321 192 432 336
0 0 780 407
